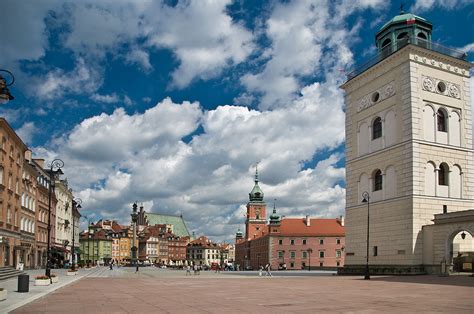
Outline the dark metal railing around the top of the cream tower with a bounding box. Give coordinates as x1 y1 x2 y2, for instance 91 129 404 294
347 37 467 81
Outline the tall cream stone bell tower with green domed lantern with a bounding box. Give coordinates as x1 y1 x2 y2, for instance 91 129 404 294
342 12 474 273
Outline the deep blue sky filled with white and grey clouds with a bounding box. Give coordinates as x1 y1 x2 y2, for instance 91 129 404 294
0 0 474 240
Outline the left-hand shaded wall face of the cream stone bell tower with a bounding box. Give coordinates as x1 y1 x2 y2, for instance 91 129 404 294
345 47 413 265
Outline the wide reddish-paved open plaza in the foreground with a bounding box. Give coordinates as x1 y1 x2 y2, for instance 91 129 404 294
6 268 474 313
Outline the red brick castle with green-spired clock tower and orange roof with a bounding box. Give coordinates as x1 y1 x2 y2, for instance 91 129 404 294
235 172 345 269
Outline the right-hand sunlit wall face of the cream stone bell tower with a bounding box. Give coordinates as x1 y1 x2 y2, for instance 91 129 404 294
410 47 474 263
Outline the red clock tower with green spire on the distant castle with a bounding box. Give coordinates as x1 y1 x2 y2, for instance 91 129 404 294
245 168 267 240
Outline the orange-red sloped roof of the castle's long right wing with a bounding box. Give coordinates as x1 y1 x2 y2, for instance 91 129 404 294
280 218 345 237
